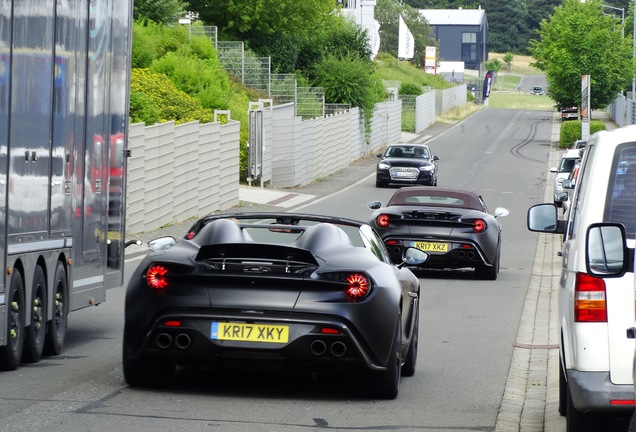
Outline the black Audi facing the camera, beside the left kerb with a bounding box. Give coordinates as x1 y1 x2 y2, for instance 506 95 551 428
375 143 439 187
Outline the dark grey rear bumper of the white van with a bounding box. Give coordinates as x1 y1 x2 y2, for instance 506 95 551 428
567 369 635 412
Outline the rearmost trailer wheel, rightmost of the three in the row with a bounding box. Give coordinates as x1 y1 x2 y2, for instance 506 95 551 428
44 261 68 355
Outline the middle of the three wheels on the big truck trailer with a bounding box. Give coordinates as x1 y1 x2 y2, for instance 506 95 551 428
23 266 48 363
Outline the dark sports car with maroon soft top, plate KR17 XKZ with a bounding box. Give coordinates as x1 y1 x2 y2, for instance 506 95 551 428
369 186 509 280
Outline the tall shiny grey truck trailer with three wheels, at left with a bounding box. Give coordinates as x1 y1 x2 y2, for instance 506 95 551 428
0 0 132 370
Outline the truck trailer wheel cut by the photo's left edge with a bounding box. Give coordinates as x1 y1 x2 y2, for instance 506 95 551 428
0 269 25 370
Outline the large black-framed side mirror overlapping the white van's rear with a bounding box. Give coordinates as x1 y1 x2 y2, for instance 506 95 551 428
585 223 628 277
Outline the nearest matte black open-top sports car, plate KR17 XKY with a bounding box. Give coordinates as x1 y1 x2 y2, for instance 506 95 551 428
123 213 427 398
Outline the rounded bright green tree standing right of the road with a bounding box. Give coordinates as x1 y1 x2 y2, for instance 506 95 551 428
530 0 634 109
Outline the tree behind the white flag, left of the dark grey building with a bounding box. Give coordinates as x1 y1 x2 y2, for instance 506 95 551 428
375 0 437 67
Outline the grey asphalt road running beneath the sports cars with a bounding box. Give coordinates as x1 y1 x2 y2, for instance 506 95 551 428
0 109 620 432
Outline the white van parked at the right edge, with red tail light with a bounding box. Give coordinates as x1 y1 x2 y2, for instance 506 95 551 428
528 126 636 431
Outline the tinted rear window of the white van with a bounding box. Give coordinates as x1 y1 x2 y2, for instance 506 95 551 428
604 142 636 239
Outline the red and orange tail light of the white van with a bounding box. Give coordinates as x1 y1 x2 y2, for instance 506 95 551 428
574 273 607 322
